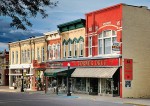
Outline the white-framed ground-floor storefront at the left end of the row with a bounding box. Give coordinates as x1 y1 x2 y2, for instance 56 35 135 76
9 64 33 90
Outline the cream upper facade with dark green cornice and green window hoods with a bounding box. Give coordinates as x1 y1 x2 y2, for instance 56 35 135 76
58 19 85 59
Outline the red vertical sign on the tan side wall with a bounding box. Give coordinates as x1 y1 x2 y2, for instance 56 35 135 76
124 59 133 80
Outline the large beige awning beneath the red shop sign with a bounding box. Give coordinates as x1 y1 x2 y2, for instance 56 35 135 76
71 67 118 78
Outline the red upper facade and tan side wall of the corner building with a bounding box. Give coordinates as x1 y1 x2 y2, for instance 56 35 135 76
86 4 150 98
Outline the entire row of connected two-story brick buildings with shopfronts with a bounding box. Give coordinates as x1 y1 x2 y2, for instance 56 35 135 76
9 4 150 98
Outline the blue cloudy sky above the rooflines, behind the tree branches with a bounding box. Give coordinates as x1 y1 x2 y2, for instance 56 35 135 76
0 0 150 51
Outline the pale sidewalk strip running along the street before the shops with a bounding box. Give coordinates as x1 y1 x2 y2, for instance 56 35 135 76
0 86 150 106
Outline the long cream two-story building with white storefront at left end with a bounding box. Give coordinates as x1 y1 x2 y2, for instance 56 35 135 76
9 36 47 90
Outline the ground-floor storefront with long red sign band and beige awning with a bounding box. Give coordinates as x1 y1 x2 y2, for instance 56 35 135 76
45 57 120 96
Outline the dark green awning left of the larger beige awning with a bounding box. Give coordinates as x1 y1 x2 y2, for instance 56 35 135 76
44 68 75 77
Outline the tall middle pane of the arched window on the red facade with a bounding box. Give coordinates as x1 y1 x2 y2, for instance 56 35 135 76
104 38 111 54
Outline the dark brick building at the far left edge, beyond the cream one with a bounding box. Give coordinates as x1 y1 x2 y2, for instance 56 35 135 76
0 50 9 86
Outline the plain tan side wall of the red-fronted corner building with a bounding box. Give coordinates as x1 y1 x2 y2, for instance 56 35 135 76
122 5 150 98
